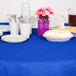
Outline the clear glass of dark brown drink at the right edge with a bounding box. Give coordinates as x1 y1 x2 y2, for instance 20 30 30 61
68 8 76 26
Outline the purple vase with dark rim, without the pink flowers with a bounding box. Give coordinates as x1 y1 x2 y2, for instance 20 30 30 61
38 15 49 35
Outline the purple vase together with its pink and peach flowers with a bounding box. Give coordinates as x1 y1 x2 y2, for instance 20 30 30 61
35 7 54 35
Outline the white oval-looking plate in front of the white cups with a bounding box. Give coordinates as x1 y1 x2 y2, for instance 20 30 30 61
1 35 27 43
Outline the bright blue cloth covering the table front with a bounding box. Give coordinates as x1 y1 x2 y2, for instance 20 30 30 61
0 23 76 76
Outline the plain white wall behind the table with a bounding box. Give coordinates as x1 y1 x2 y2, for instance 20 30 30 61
0 0 76 26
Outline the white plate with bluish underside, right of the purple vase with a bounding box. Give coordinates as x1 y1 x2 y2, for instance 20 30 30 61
43 30 73 42
